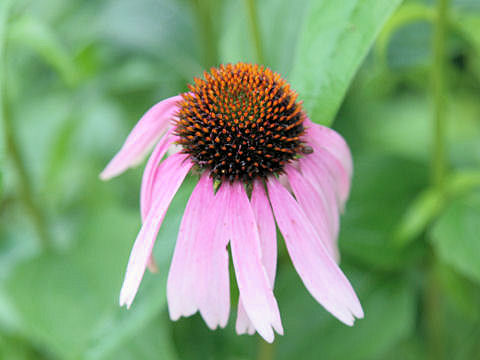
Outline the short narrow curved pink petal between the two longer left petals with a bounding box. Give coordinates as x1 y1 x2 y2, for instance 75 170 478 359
140 129 175 221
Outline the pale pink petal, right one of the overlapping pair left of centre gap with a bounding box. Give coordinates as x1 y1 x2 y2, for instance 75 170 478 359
194 186 231 329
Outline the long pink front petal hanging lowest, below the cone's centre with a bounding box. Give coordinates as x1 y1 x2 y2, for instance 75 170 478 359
229 182 281 342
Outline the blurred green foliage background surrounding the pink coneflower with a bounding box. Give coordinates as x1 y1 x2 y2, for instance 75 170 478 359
0 0 480 360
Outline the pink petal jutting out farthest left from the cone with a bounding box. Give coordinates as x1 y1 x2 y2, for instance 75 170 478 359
100 95 182 180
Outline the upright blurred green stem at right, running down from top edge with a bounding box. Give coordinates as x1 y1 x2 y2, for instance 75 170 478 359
432 0 449 187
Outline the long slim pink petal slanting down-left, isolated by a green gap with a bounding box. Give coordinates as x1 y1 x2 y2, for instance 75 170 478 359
120 154 192 308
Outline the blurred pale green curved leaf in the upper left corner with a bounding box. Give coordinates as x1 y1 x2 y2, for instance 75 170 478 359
9 16 78 86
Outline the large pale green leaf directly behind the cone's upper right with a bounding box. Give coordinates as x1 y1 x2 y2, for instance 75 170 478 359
291 0 400 125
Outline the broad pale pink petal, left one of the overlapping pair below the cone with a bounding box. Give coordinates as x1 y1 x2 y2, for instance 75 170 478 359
167 174 214 320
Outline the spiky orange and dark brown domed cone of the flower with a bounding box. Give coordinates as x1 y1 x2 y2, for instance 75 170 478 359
176 63 304 182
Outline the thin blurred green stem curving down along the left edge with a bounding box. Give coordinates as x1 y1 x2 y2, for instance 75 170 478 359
0 0 49 248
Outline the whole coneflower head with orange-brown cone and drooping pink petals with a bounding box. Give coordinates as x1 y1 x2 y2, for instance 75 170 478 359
101 63 363 342
